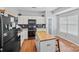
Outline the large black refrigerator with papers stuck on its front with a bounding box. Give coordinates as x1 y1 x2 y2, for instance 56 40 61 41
0 14 20 52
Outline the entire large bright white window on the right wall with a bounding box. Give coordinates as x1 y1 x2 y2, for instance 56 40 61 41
59 15 78 36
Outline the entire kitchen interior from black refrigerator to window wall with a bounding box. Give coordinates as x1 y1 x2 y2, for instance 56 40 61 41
0 7 79 52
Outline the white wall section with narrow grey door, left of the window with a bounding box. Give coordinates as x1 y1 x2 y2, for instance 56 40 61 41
45 10 57 35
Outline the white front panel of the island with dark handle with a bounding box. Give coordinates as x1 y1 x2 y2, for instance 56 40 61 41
40 40 56 52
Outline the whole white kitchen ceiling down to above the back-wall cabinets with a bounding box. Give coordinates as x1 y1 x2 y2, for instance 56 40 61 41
6 7 58 16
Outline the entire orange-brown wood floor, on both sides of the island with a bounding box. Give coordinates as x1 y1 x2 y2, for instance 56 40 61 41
20 38 79 52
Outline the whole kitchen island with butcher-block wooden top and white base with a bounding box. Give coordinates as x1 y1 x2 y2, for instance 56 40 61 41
36 31 56 52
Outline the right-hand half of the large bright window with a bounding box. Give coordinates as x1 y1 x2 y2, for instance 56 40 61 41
68 15 78 35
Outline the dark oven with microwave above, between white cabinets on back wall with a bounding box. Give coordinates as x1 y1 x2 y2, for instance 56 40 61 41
28 19 36 38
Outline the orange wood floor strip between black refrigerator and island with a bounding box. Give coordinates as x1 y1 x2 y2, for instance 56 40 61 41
20 39 37 52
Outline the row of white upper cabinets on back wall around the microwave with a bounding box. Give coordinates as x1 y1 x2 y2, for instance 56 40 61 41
18 16 46 24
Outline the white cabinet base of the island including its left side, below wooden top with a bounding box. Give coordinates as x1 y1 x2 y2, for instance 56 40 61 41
36 40 56 52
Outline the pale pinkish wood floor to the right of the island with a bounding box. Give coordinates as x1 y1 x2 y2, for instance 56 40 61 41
58 37 79 52
